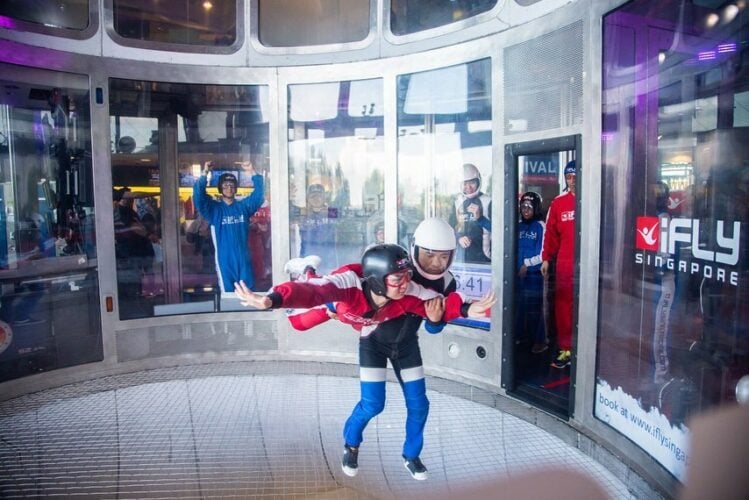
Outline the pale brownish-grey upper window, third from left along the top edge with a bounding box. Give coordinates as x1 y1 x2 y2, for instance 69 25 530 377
258 0 371 47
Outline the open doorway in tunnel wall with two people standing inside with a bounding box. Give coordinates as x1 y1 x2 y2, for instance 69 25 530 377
502 135 581 419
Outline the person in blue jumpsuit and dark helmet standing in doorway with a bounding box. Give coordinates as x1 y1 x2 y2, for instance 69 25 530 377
515 191 548 354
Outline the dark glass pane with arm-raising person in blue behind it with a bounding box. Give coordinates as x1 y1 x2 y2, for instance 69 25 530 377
110 80 271 319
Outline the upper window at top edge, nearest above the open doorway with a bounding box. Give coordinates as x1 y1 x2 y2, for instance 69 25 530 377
390 0 497 35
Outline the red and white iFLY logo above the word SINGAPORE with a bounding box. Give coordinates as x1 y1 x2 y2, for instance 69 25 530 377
635 216 741 266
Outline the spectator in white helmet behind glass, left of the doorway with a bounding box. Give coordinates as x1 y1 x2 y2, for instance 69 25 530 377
455 163 491 263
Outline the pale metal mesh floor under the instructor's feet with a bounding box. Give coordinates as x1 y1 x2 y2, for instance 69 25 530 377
0 363 630 498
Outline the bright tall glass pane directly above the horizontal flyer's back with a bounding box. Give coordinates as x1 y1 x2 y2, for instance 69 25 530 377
289 79 385 273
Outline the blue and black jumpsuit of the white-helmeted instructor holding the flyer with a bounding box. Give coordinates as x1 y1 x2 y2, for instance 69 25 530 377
343 272 456 459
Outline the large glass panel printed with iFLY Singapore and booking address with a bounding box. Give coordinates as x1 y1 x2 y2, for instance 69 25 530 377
595 1 749 481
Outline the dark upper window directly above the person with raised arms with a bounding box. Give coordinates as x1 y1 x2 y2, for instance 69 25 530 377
112 0 237 47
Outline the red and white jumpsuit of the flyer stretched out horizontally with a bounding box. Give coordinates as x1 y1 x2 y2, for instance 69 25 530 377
268 264 470 337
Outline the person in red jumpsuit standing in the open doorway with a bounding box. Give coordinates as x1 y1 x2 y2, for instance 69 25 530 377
541 160 577 369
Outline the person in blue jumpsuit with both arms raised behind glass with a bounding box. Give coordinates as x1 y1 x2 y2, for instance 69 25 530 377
193 162 264 292
